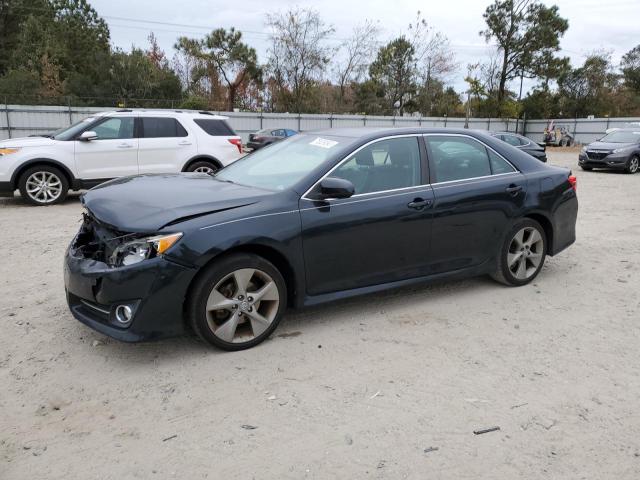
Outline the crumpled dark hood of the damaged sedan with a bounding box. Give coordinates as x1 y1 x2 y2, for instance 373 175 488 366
82 173 271 233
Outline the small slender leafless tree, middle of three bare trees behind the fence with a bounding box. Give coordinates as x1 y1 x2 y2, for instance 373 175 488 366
335 20 380 103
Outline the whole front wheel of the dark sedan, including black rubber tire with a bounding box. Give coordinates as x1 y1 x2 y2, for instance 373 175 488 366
186 253 287 351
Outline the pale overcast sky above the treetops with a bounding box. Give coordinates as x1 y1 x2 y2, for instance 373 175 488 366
91 0 640 91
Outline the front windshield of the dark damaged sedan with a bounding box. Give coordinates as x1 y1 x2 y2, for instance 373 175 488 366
216 135 352 190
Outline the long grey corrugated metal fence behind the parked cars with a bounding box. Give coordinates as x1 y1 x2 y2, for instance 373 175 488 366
0 104 640 143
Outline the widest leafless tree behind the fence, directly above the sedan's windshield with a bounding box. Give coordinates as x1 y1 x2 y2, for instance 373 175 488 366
267 7 335 112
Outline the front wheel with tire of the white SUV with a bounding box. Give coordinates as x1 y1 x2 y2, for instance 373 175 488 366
18 165 69 205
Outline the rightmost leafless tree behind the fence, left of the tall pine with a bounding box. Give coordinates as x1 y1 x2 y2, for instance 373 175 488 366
409 11 459 114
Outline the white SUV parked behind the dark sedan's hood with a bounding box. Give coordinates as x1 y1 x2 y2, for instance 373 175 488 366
0 110 242 205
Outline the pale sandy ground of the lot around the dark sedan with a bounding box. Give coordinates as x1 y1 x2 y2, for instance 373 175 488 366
0 150 640 480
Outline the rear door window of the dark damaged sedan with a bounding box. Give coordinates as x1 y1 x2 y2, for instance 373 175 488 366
425 135 491 182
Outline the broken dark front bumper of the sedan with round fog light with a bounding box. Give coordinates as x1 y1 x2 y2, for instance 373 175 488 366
64 217 196 342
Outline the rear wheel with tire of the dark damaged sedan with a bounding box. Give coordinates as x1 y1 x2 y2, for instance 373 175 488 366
492 218 547 287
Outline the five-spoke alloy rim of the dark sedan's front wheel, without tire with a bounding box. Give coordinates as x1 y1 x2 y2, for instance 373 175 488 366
206 268 280 343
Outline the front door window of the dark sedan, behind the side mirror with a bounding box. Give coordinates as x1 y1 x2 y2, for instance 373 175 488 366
331 137 421 194
